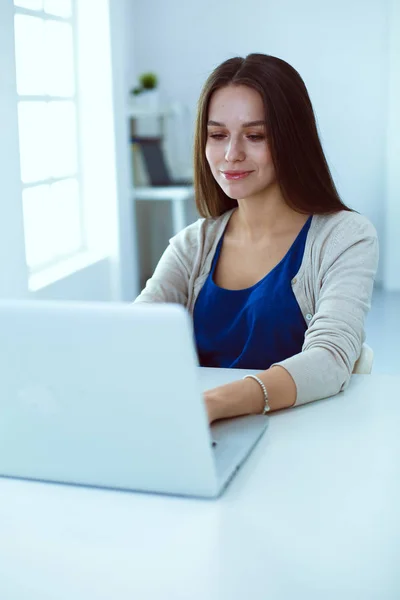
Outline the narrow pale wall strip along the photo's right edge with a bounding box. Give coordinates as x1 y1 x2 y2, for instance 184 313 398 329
384 0 400 290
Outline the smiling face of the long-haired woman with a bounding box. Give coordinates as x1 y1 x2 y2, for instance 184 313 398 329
206 85 276 199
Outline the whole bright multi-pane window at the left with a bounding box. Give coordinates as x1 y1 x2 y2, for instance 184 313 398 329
14 0 86 274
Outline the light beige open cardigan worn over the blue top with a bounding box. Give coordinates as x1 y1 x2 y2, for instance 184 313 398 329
135 210 378 404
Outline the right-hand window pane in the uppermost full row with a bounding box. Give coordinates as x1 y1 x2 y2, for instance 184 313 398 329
45 20 75 96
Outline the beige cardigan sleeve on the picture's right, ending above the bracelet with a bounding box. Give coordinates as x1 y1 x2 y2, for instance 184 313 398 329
272 221 379 405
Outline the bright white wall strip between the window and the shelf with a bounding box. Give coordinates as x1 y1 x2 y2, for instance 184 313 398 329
77 0 138 300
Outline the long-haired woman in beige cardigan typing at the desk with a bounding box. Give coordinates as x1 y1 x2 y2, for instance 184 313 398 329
136 54 378 422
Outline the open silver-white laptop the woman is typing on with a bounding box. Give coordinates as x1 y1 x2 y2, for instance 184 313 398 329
0 300 268 497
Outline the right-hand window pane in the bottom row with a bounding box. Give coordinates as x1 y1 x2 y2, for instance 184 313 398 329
50 179 83 255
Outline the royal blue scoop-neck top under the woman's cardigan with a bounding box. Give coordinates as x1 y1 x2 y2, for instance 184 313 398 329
193 215 312 370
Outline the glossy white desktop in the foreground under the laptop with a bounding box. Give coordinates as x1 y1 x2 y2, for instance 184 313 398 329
0 375 400 600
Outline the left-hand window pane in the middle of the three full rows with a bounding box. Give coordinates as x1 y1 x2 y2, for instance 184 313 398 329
18 102 51 183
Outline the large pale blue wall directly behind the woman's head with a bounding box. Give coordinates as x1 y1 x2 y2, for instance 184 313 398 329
127 0 390 279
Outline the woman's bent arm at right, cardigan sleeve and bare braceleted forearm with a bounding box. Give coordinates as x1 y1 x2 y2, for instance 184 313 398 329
205 222 379 422
